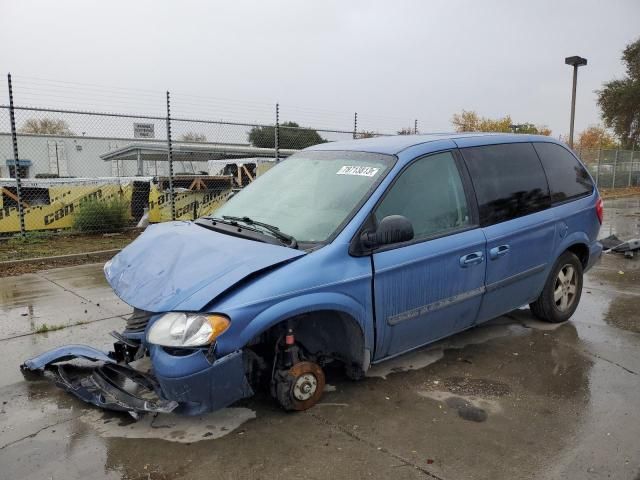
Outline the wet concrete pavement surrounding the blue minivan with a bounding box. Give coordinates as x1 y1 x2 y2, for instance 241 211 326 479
0 198 640 480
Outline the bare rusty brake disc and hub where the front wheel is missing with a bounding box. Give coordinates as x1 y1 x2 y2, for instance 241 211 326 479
275 362 325 411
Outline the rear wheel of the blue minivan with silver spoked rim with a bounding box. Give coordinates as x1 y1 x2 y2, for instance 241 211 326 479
529 251 583 323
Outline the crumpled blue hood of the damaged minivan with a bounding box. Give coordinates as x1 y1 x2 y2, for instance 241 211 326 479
104 222 305 312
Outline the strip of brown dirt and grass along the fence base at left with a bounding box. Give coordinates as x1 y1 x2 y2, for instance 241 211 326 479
0 230 141 277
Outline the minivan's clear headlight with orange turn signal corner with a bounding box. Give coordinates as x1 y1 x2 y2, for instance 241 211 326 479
147 312 230 347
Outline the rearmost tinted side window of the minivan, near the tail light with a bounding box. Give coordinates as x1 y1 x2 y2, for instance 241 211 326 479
533 143 593 203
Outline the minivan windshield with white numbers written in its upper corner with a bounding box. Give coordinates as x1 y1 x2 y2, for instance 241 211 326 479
214 151 395 243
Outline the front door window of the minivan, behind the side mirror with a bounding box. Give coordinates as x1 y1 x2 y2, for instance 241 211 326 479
375 152 469 238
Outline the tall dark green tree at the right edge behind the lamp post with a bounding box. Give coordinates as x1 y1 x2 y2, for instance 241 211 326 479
596 39 640 148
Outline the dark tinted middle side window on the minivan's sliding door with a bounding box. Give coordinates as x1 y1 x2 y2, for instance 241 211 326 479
460 143 551 226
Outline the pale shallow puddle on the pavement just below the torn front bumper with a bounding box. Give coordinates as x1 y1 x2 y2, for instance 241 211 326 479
79 407 256 443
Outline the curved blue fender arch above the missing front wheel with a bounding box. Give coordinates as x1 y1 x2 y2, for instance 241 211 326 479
218 292 373 354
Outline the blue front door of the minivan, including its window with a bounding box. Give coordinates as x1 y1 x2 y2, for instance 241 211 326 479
373 151 486 359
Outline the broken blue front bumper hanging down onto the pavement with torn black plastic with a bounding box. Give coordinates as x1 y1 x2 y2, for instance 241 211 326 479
20 345 253 417
